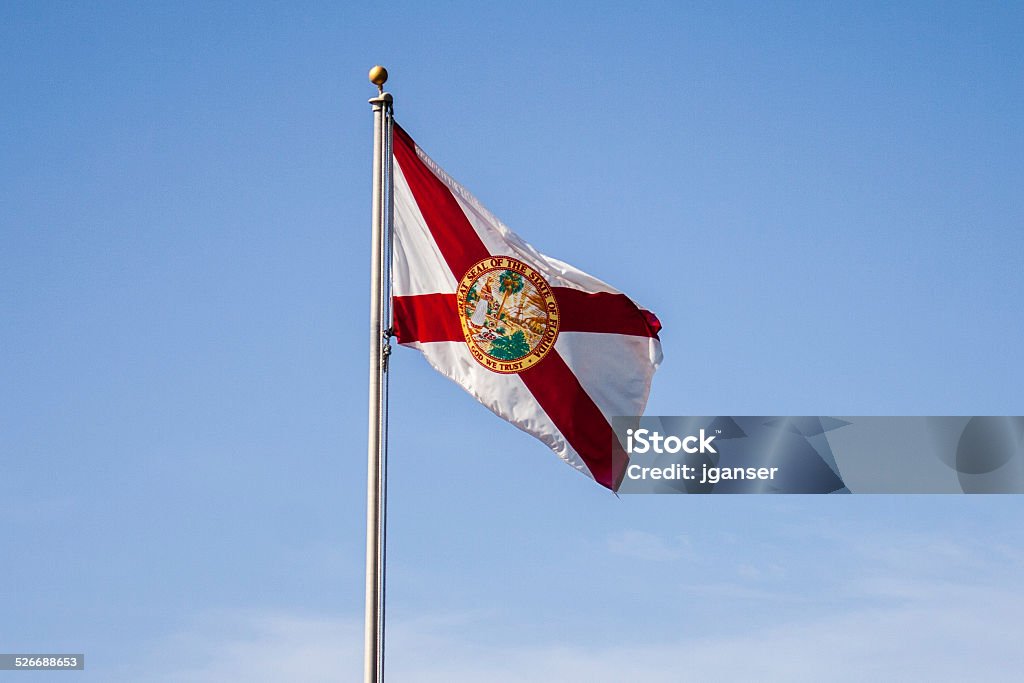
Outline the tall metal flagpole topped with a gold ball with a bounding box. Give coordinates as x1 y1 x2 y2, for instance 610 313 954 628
362 67 392 683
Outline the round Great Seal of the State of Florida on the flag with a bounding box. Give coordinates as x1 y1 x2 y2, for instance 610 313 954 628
456 256 559 374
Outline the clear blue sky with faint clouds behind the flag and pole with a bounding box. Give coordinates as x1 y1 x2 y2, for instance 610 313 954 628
0 2 1024 682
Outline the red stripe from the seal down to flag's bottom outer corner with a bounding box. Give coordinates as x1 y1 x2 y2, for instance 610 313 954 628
519 349 629 490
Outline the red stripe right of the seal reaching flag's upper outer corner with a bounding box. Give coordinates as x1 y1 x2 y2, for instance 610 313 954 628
551 287 662 339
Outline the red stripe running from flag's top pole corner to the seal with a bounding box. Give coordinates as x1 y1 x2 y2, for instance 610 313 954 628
393 124 490 282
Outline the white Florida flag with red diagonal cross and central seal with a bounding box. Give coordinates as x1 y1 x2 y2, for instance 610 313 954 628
392 124 662 490
